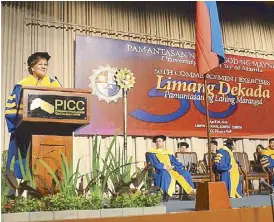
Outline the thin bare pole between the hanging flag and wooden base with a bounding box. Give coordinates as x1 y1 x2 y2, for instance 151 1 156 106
204 74 215 182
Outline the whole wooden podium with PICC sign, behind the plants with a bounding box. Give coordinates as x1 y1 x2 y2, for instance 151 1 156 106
16 86 90 195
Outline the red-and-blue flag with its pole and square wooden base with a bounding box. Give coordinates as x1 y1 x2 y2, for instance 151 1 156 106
195 1 231 210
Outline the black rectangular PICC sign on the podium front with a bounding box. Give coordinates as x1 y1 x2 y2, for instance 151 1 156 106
28 94 87 119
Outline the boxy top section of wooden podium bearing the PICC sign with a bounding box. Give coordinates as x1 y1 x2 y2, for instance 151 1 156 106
17 86 90 135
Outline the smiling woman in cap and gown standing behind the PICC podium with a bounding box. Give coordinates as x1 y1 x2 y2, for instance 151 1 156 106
5 52 60 179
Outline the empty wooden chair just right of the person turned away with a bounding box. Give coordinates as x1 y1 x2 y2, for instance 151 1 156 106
233 152 269 196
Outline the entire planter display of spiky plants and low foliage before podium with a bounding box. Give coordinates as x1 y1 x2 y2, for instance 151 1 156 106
1 136 162 212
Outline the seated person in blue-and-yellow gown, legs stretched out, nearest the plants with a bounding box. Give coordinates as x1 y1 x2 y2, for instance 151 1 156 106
147 136 194 201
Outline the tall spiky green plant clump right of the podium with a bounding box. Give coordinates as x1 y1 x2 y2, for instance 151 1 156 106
84 135 150 197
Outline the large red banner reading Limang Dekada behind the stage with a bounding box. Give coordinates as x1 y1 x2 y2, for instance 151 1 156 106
75 35 274 138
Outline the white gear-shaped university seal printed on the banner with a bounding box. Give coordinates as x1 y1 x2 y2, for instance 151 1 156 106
89 65 122 103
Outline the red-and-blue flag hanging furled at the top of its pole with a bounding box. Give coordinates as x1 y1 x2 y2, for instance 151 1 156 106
196 1 225 74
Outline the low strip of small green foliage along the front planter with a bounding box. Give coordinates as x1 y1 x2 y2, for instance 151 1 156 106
6 190 162 213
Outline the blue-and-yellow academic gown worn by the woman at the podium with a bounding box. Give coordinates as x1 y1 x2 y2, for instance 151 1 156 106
5 75 60 179
